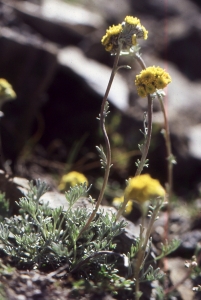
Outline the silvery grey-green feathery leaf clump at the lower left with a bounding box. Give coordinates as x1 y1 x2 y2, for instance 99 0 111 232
0 181 125 274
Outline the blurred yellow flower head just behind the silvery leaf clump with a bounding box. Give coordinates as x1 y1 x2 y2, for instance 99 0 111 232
59 171 88 191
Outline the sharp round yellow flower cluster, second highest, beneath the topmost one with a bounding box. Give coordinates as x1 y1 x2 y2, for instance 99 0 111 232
135 66 172 98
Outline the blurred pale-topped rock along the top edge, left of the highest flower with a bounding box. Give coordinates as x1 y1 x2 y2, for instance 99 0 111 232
14 0 103 45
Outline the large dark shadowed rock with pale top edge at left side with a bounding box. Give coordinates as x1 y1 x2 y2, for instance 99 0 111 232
0 7 57 162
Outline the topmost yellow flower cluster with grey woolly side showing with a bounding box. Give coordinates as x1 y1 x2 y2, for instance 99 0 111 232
101 16 148 54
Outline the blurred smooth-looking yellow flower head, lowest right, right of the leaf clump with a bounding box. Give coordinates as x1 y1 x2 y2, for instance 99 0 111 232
124 174 165 204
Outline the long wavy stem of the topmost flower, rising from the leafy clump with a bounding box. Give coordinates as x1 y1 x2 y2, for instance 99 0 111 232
79 46 121 237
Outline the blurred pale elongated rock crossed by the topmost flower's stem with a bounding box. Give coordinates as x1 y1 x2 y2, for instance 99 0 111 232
58 47 129 111
